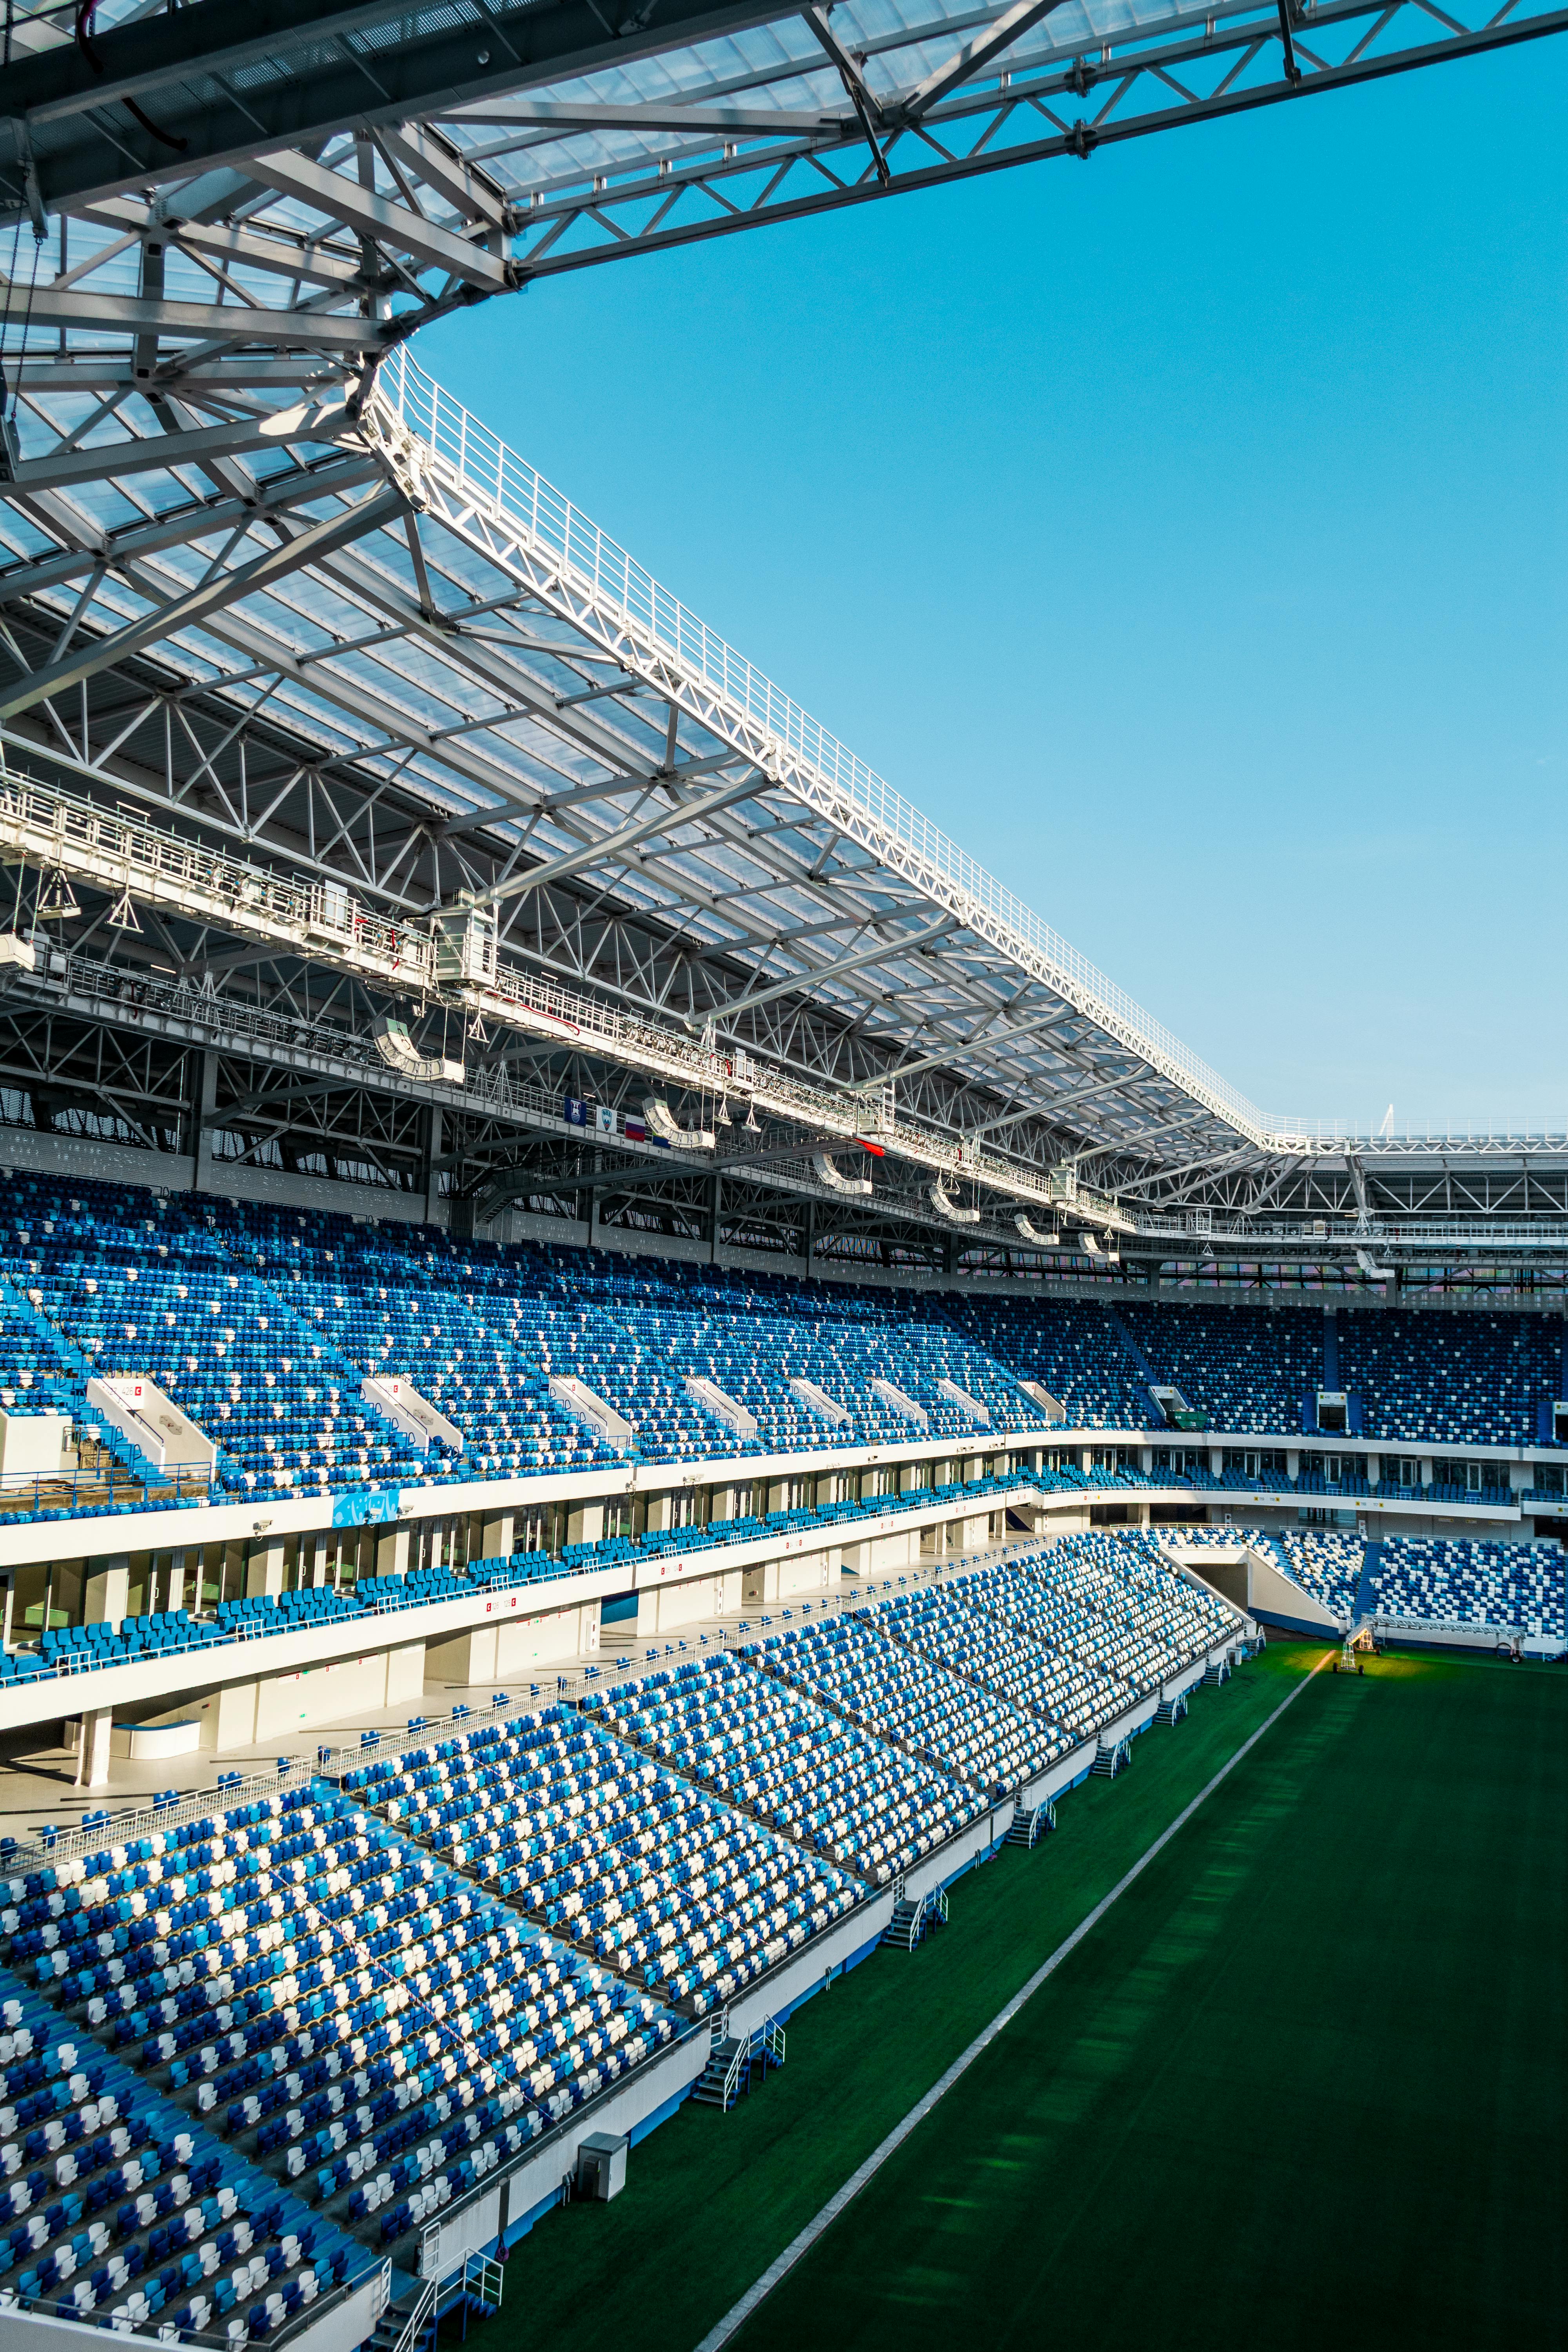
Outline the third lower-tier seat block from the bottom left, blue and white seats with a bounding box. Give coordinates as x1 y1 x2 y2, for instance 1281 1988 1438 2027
343 1708 856 2016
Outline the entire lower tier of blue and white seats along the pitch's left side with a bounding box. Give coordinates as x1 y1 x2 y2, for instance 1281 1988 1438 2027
0 1538 1236 2347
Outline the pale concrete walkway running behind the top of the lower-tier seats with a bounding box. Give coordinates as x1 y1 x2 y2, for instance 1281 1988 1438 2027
0 1536 1034 1844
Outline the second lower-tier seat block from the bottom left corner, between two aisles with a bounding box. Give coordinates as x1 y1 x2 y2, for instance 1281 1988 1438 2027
0 1783 675 2277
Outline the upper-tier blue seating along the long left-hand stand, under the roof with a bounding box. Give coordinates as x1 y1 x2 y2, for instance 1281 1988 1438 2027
0 1174 1039 1491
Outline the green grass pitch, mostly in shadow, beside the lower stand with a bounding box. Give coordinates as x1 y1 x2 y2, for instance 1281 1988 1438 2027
477 1646 1568 2352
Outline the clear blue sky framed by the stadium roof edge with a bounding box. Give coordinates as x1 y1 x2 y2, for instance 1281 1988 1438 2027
418 38 1568 1134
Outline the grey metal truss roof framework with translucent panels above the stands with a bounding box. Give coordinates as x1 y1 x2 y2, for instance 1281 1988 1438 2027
0 0 1568 1265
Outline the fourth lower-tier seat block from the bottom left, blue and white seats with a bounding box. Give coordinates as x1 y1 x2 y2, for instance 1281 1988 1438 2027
583 1653 983 1886
